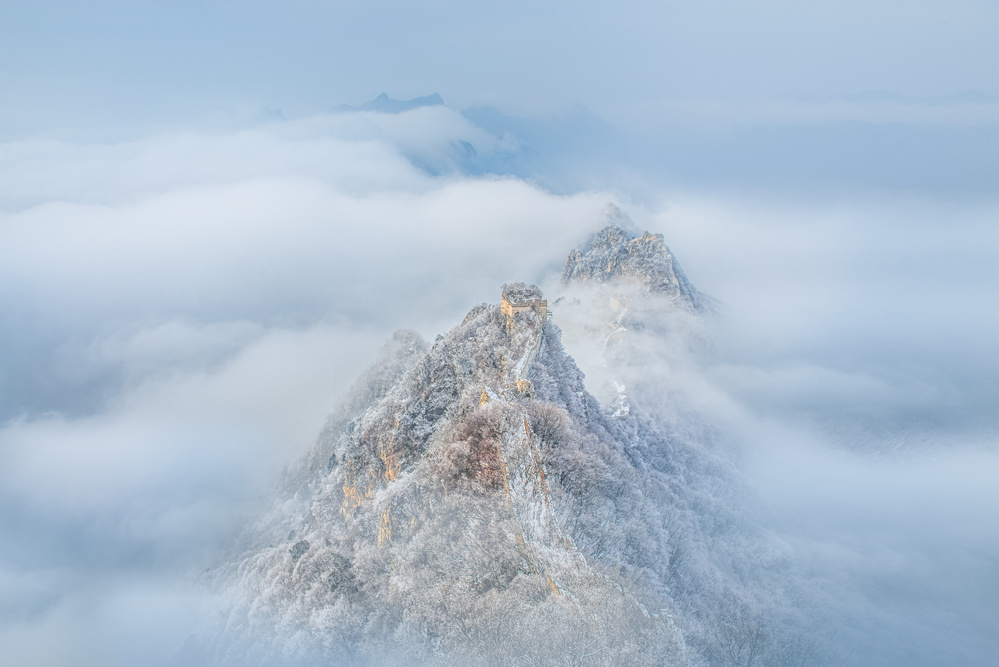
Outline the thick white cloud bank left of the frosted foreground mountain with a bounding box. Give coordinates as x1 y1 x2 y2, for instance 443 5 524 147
0 113 606 664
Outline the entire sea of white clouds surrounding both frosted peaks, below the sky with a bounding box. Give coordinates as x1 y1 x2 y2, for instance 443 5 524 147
0 106 999 665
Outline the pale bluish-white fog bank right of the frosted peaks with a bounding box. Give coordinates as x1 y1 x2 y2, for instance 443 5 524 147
624 196 999 665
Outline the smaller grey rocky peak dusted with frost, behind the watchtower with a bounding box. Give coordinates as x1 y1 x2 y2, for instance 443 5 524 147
562 225 704 309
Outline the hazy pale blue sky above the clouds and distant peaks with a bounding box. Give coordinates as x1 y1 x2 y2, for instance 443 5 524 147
0 0 999 124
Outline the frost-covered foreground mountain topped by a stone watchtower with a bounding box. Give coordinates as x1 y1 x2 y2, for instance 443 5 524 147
206 228 812 665
